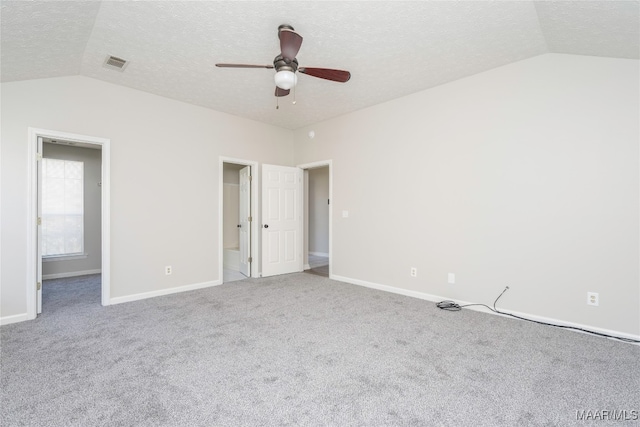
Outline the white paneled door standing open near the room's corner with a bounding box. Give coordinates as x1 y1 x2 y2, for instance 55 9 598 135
262 165 303 277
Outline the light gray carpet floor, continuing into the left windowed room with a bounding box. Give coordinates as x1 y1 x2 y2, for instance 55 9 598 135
0 273 640 427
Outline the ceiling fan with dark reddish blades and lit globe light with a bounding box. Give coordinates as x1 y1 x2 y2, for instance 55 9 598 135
216 24 351 97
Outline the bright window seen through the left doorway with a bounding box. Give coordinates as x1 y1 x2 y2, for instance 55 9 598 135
42 159 84 257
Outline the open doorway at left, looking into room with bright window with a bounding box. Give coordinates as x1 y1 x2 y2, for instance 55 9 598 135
38 142 102 313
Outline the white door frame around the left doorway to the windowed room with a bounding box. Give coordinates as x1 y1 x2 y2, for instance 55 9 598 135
26 127 111 320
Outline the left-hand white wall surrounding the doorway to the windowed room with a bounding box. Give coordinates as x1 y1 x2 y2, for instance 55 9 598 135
0 77 293 318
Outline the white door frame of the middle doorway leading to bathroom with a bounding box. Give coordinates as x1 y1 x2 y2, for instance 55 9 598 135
218 156 260 283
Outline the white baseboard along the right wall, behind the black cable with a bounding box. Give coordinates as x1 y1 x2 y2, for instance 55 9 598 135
331 275 640 340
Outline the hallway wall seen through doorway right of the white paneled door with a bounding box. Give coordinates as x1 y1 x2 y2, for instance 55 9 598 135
308 166 329 254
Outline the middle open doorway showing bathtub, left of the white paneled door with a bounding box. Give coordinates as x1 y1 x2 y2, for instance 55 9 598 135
219 158 257 283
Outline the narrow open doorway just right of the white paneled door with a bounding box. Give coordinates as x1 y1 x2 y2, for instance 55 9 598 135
300 161 331 277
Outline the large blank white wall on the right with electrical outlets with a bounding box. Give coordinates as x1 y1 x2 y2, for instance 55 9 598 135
295 54 640 335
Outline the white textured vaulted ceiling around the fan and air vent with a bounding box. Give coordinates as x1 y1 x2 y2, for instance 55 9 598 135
1 0 640 129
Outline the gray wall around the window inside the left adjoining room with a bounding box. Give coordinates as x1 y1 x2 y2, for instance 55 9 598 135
42 143 102 279
